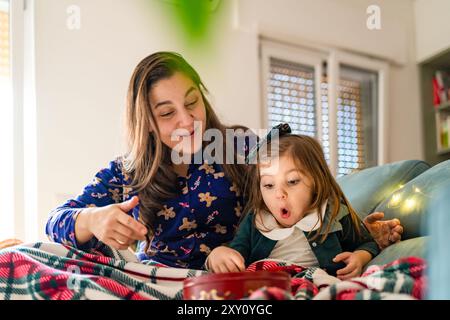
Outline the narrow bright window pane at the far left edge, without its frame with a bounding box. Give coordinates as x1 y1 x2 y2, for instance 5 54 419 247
0 0 14 239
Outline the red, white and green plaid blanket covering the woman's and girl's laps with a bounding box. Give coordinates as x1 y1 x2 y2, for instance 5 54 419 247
0 243 425 300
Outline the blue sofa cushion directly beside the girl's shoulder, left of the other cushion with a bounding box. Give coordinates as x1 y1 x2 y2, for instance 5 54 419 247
337 160 430 218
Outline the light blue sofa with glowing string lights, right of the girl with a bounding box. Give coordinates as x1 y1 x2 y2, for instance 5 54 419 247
337 160 450 268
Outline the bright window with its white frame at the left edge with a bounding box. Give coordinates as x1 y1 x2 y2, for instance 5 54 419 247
0 0 35 241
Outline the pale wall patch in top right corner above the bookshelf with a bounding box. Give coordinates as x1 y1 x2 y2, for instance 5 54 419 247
414 0 450 62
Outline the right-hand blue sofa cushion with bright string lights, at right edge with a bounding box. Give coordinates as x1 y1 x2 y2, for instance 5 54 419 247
375 160 450 239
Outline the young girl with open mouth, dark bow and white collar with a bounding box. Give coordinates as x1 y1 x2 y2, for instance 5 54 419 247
207 134 379 280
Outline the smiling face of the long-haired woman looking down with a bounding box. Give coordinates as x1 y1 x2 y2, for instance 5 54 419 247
150 72 206 154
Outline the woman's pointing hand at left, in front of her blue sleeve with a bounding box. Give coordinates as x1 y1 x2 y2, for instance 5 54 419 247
75 196 147 250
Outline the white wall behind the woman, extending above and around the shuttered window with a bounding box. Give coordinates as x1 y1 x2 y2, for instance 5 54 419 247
30 0 422 238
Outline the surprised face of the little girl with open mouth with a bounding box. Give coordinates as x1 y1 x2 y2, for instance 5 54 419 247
260 156 312 227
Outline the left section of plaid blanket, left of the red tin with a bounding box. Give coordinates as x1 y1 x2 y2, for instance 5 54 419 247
0 242 206 300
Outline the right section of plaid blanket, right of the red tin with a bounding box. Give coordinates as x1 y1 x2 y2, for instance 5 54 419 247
247 257 426 300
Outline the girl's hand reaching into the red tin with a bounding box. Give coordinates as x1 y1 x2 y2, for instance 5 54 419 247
208 246 245 273
